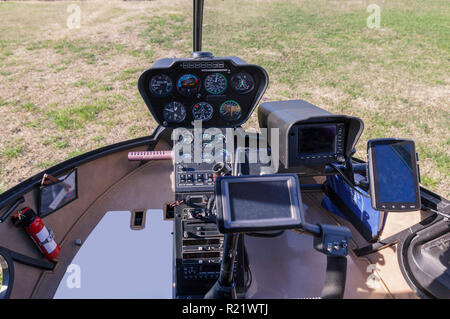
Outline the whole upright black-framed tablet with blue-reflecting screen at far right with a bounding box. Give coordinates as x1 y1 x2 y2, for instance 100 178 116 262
367 139 420 212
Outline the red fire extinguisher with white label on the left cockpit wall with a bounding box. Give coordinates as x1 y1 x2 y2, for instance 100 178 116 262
12 207 61 260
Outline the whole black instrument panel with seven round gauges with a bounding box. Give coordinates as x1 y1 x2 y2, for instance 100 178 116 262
139 57 268 127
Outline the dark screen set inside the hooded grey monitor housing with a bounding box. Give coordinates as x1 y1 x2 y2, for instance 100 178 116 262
298 124 337 155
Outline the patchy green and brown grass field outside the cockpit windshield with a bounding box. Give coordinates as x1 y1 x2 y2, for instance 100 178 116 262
0 0 450 198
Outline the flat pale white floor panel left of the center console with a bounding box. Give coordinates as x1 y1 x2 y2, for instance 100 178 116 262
55 210 173 298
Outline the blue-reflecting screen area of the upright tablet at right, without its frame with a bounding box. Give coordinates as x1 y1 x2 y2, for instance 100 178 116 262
375 144 417 203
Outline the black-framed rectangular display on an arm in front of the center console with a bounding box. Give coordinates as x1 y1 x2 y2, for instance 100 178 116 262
216 174 304 233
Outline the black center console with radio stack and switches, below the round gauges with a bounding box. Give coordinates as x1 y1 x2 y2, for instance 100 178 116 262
173 129 244 298
